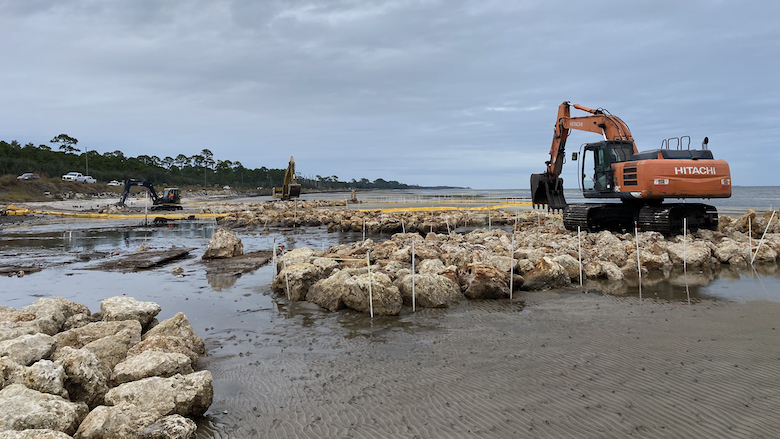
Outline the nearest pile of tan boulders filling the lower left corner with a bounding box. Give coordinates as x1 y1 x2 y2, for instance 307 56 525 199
0 296 214 439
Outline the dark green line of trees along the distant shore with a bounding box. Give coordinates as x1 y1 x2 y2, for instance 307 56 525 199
0 134 418 190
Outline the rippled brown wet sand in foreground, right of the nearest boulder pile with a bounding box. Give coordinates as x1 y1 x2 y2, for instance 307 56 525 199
198 293 780 438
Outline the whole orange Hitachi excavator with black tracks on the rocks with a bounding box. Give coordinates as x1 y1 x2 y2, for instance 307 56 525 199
531 102 731 234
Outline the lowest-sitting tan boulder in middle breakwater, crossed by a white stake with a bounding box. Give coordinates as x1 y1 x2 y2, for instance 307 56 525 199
342 270 403 315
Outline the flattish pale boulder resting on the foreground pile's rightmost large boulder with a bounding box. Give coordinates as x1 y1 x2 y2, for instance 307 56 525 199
114 350 193 384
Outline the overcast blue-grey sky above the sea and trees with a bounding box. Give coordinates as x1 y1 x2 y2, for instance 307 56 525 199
0 0 780 189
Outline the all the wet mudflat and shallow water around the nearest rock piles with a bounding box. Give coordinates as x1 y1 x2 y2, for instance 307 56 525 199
0 199 780 438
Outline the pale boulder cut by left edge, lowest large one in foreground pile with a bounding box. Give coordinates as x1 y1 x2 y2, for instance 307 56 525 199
0 384 89 435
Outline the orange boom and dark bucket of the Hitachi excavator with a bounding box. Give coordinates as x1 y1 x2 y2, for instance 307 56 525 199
531 101 637 210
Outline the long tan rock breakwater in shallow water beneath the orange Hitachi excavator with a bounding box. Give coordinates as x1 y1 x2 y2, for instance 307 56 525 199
273 212 780 315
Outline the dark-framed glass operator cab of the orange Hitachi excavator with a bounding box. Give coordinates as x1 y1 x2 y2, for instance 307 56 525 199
580 140 634 198
